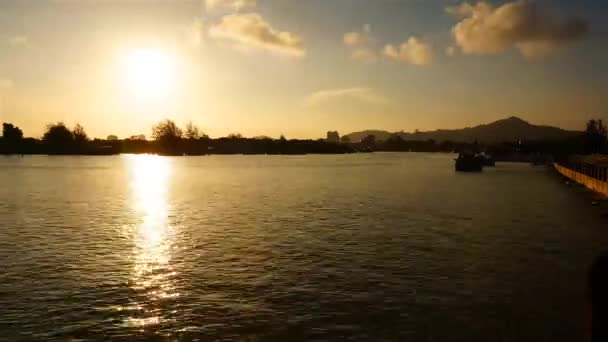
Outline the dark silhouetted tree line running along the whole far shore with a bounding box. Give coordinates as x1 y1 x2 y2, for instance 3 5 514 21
0 119 608 156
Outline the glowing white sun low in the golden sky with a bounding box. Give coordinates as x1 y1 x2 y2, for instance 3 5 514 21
121 48 178 100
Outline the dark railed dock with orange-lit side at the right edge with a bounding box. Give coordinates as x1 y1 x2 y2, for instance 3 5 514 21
553 154 608 196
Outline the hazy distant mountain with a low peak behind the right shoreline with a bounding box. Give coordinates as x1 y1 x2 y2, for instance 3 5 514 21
347 116 578 143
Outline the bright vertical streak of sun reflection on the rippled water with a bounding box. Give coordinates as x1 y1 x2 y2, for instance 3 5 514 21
125 155 179 327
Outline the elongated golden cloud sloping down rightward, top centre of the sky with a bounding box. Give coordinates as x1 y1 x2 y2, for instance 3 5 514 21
209 13 306 57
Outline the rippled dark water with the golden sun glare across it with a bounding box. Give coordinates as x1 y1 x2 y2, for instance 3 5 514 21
0 154 608 341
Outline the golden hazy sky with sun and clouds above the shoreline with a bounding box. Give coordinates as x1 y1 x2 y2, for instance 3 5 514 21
0 0 608 138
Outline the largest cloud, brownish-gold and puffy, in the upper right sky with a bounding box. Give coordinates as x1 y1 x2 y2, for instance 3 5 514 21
447 0 587 59
